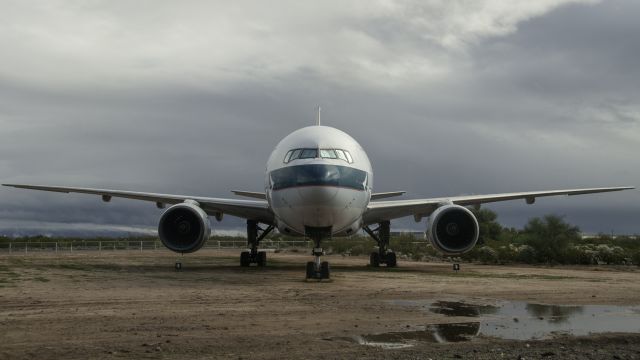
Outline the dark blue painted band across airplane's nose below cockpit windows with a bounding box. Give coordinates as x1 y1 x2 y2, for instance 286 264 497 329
269 164 367 190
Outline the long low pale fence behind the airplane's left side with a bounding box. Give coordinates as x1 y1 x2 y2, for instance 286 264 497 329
0 240 313 254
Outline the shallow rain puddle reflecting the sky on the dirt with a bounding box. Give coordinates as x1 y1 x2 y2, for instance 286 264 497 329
355 300 640 349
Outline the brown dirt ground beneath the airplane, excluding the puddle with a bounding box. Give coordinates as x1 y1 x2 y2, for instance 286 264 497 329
0 250 640 359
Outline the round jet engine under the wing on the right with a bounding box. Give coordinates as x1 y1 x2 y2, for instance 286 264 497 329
426 205 480 255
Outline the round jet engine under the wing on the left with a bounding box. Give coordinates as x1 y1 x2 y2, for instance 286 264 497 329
158 201 211 253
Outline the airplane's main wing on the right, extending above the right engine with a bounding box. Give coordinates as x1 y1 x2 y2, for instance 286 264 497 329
364 186 634 224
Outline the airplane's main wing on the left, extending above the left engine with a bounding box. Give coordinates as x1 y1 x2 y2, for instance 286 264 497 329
2 184 274 224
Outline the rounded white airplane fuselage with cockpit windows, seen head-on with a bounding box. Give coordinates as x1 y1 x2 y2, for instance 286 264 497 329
265 126 373 236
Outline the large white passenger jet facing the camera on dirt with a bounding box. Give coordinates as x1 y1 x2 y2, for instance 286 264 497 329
3 108 634 280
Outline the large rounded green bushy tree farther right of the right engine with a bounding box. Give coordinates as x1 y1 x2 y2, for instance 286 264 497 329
523 215 580 263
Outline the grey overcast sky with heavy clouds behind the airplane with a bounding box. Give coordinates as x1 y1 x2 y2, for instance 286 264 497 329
0 0 640 235
